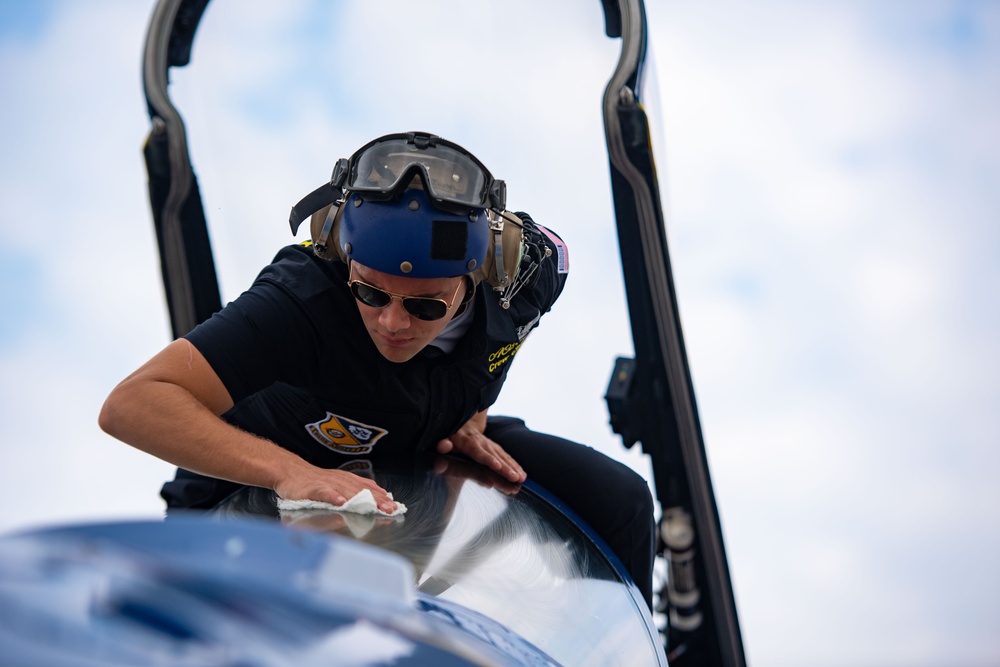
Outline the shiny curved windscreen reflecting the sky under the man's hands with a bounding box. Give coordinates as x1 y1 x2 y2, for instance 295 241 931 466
216 457 658 667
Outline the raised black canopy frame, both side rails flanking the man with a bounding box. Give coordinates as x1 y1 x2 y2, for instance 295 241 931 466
142 0 746 667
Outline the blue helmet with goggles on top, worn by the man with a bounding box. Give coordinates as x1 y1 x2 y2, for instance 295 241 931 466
290 132 508 278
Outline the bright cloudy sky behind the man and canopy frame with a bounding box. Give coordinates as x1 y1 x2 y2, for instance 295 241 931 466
0 0 1000 667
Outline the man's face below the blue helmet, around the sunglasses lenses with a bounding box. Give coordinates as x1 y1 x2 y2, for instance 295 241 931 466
352 262 465 363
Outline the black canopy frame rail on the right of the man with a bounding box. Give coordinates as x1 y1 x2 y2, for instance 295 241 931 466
602 0 746 667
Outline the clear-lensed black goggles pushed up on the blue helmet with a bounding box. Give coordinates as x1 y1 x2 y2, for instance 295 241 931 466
330 132 507 213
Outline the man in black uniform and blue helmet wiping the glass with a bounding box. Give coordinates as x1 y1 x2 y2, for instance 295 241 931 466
100 132 655 602
